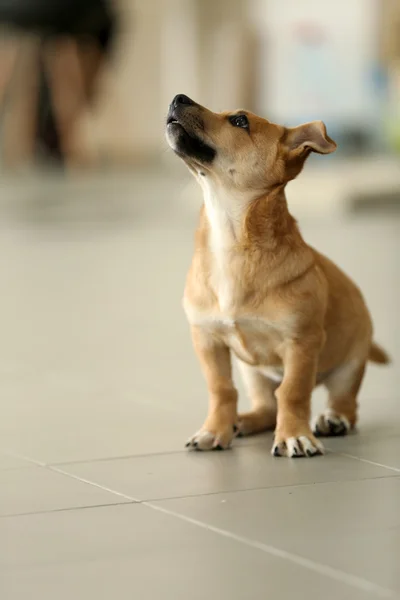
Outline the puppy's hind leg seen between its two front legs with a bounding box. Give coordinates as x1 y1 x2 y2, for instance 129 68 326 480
237 360 278 435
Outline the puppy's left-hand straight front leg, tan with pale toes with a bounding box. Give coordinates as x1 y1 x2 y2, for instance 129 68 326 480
186 327 237 450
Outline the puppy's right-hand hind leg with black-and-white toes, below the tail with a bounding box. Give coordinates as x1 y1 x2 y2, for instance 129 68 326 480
314 362 366 436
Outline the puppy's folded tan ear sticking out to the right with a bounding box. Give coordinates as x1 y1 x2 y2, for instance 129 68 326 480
285 121 337 157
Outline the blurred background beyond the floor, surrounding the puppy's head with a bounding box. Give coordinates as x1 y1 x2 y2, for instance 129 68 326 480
0 0 400 213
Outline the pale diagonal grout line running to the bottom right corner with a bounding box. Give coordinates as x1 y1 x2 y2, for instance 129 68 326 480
146 502 398 600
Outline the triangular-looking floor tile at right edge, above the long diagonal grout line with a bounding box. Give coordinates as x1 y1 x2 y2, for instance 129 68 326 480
157 478 400 594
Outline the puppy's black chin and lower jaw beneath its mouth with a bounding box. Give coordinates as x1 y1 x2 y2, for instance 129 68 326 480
167 121 216 165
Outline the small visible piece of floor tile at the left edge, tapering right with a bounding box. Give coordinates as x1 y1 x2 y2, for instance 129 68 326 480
0 467 130 516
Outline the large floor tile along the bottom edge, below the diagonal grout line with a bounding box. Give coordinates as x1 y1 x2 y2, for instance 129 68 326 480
0 505 378 600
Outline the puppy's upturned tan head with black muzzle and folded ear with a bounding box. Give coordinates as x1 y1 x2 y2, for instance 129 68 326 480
166 94 336 191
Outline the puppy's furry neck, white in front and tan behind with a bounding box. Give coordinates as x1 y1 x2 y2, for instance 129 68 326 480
197 177 313 314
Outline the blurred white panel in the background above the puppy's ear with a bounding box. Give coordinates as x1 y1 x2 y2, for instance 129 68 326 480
251 0 379 123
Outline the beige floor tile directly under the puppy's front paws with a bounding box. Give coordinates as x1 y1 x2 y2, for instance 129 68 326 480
61 436 395 500
